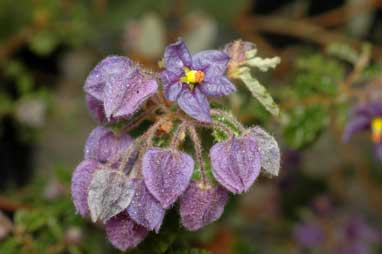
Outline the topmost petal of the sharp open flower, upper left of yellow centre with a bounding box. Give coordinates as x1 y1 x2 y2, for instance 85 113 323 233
164 39 192 73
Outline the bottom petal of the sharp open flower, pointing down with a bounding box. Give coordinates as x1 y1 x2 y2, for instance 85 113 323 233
177 87 212 123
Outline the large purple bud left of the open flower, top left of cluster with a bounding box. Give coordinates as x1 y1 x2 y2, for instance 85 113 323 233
84 56 158 122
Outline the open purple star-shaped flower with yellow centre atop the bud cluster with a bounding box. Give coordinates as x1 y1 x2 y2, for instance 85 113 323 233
161 39 236 122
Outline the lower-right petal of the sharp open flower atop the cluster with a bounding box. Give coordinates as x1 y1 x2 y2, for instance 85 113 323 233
199 76 236 97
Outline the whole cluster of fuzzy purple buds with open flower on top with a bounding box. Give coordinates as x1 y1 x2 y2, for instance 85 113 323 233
72 39 280 250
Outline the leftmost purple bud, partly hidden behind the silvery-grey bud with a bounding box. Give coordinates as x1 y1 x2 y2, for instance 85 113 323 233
72 160 101 217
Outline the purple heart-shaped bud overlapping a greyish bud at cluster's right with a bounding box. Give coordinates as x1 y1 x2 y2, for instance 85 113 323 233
210 134 261 194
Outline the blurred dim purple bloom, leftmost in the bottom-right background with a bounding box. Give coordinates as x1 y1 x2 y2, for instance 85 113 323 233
294 223 324 247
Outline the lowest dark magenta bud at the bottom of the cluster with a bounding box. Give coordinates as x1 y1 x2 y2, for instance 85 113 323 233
105 212 148 251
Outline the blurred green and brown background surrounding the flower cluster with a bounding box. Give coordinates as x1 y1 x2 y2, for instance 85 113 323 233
0 0 382 254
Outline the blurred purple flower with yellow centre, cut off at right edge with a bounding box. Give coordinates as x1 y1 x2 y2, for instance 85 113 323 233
343 101 382 161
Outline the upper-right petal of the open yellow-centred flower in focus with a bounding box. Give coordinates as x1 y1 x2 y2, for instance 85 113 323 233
192 50 229 80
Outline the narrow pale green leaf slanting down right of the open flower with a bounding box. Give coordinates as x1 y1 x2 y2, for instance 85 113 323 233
238 67 280 116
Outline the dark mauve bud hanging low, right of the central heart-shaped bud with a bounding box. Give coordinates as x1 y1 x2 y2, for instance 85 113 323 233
180 182 228 231
